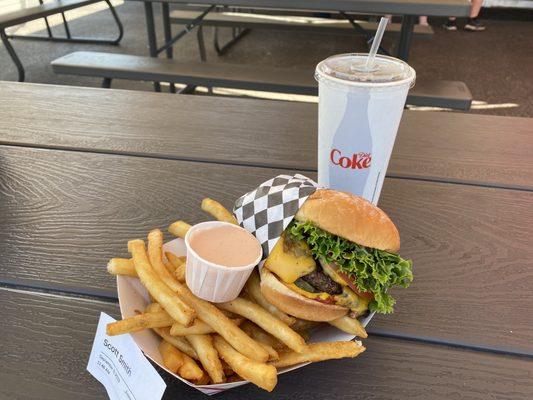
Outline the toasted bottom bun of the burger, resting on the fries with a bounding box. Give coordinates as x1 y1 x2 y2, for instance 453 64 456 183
261 268 348 321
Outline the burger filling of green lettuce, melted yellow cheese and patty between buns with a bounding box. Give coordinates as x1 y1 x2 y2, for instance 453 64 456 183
265 221 413 316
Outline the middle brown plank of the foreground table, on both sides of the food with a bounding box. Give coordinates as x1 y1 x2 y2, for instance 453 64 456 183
0 146 533 355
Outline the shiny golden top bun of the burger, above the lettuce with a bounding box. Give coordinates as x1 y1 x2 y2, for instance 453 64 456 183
295 189 400 253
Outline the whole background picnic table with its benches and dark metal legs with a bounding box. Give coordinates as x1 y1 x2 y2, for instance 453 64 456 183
52 0 472 110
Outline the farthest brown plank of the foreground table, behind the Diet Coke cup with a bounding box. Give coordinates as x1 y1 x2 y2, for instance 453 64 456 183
0 83 533 190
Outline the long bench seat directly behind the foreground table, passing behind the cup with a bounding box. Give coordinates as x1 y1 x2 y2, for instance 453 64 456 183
52 51 472 110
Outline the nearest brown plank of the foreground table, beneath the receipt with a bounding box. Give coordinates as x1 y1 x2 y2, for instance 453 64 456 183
0 289 533 400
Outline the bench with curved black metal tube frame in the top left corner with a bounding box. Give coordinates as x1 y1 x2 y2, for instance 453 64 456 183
0 0 124 82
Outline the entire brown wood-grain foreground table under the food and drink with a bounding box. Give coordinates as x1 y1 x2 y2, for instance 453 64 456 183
0 83 533 399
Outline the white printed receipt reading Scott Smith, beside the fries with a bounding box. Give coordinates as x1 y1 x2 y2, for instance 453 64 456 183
87 313 166 400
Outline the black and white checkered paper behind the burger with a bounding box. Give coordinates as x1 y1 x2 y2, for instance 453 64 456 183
233 174 318 258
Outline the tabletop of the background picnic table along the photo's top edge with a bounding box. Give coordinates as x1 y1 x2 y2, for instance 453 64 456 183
122 0 470 17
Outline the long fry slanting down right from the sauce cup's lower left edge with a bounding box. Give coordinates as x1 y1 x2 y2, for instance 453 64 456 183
169 283 268 362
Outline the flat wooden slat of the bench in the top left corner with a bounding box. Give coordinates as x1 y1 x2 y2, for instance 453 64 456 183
0 0 102 28
